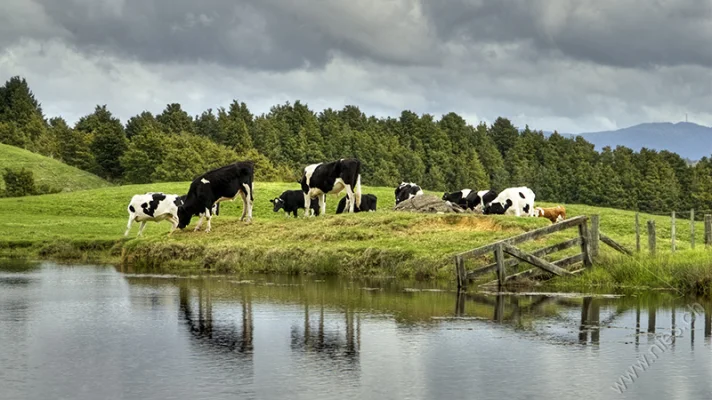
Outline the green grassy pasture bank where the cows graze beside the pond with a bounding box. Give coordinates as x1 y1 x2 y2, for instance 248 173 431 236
0 182 712 288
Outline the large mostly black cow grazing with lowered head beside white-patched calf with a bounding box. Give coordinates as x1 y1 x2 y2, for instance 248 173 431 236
178 161 255 232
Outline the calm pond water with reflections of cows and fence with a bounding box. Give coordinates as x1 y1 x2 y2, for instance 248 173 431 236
0 263 712 400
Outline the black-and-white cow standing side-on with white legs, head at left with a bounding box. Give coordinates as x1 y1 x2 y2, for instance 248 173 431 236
299 158 361 217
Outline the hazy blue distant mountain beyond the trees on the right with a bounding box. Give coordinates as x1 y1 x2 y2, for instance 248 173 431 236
580 122 712 160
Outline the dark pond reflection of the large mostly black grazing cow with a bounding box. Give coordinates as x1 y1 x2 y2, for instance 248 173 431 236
179 285 254 359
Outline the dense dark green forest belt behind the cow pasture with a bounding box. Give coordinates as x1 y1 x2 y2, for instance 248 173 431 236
0 77 712 212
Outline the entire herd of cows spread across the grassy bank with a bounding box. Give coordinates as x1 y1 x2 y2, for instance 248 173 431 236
124 158 566 236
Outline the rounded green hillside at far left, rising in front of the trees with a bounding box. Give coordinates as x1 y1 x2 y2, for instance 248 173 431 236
0 144 109 192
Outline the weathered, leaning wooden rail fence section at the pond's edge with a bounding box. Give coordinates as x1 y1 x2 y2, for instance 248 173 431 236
455 215 633 290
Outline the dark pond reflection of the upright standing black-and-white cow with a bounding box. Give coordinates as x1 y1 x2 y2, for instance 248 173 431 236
291 303 361 363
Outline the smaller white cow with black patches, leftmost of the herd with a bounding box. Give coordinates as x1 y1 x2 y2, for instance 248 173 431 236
124 192 219 236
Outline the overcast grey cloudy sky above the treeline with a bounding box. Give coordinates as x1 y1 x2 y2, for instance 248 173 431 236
0 0 712 132
